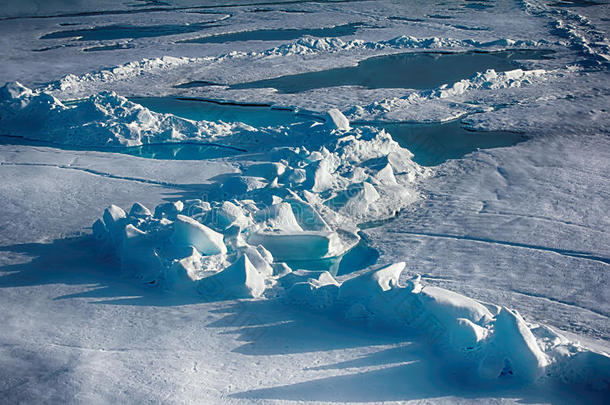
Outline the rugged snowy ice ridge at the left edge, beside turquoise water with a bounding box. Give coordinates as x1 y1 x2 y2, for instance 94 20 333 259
0 82 252 146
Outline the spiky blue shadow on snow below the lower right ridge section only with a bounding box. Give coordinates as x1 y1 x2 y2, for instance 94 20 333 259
207 300 604 404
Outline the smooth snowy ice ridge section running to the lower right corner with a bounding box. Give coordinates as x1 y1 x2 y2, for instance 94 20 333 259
332 263 610 384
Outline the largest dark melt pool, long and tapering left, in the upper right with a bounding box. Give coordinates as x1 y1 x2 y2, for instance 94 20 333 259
230 50 552 93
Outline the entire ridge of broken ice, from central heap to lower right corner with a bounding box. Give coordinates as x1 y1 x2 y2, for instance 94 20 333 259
78 87 610 389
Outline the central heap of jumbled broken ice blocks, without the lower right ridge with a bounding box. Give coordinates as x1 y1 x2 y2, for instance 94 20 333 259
91 100 429 298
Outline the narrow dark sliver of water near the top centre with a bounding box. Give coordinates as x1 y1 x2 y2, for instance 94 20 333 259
180 23 363 44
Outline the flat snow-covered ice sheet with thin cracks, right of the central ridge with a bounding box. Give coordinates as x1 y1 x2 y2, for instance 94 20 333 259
368 133 610 341
